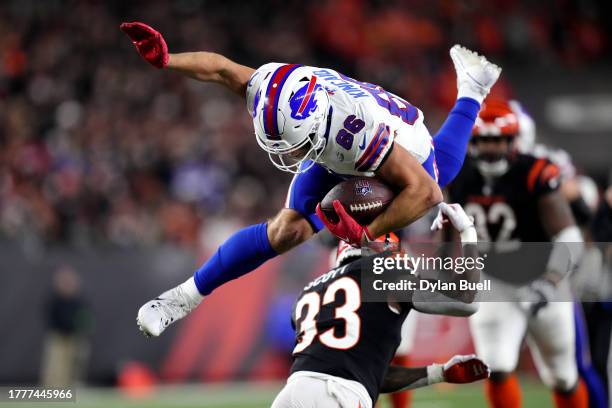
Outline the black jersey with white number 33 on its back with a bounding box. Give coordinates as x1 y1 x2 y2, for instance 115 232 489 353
291 258 410 402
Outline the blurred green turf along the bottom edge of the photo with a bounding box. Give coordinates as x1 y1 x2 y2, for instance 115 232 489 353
0 380 552 408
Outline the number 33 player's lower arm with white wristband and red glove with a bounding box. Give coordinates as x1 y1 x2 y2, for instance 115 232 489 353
380 354 490 394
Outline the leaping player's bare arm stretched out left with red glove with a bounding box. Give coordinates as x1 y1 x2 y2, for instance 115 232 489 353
120 22 255 97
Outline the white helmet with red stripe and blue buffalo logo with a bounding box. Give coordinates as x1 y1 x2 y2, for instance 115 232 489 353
247 63 330 173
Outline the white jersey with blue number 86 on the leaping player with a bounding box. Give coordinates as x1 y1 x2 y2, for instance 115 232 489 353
247 63 433 176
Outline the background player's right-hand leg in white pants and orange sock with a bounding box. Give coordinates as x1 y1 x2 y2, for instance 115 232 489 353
527 302 588 408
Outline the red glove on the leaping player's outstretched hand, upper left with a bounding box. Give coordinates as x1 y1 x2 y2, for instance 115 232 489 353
119 22 168 68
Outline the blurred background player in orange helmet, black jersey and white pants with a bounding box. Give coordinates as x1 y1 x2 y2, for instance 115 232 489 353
449 100 587 408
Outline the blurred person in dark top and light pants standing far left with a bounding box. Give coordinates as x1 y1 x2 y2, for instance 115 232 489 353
41 266 93 387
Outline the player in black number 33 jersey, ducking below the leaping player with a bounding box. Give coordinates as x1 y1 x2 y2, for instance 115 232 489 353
272 203 489 408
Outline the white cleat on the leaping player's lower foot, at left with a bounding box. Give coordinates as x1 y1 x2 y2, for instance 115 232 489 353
136 278 204 337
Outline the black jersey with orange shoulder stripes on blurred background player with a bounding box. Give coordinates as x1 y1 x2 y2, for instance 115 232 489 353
448 154 559 242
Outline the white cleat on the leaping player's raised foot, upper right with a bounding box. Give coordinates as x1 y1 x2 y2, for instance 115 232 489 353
450 45 501 104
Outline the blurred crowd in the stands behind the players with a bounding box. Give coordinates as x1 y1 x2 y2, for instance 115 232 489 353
0 0 612 248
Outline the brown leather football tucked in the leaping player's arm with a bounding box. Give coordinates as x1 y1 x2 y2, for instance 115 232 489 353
321 177 395 225
